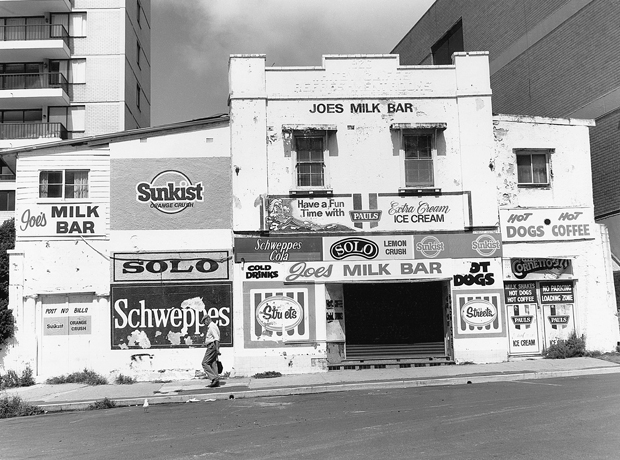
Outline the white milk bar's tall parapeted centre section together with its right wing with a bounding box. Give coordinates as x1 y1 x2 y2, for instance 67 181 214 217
229 52 618 374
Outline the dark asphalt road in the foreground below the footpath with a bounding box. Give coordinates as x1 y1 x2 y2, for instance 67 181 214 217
0 374 620 460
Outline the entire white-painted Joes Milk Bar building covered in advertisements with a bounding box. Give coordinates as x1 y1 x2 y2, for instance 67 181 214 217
0 53 619 380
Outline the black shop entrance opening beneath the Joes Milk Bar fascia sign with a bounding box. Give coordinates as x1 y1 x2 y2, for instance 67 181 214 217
343 281 444 346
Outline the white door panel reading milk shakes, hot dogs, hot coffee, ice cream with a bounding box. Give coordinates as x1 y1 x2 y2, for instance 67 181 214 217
504 281 540 354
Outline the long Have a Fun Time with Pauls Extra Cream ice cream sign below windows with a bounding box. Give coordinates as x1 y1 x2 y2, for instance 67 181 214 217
266 193 471 233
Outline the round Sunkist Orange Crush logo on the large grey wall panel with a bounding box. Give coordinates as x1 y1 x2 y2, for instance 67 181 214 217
136 170 204 214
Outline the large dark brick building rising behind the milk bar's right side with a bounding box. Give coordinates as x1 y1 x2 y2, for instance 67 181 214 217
392 0 620 269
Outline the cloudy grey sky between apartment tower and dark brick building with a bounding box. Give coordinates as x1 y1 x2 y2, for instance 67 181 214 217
151 0 434 126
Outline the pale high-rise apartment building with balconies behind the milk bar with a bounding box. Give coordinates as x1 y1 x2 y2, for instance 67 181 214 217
0 0 151 221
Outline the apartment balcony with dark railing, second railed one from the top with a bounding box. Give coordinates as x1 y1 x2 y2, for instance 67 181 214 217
0 72 71 109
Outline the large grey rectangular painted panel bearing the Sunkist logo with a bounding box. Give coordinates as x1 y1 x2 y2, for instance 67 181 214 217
110 157 232 230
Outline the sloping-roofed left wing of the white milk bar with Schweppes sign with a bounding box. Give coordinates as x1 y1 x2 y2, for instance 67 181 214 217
0 117 232 381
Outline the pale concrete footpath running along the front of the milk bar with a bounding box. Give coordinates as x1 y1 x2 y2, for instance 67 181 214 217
0 358 620 412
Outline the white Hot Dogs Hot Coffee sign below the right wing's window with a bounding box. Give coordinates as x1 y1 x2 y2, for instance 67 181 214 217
499 208 594 243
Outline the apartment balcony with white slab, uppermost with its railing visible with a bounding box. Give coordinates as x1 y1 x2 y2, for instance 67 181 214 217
0 24 71 62
